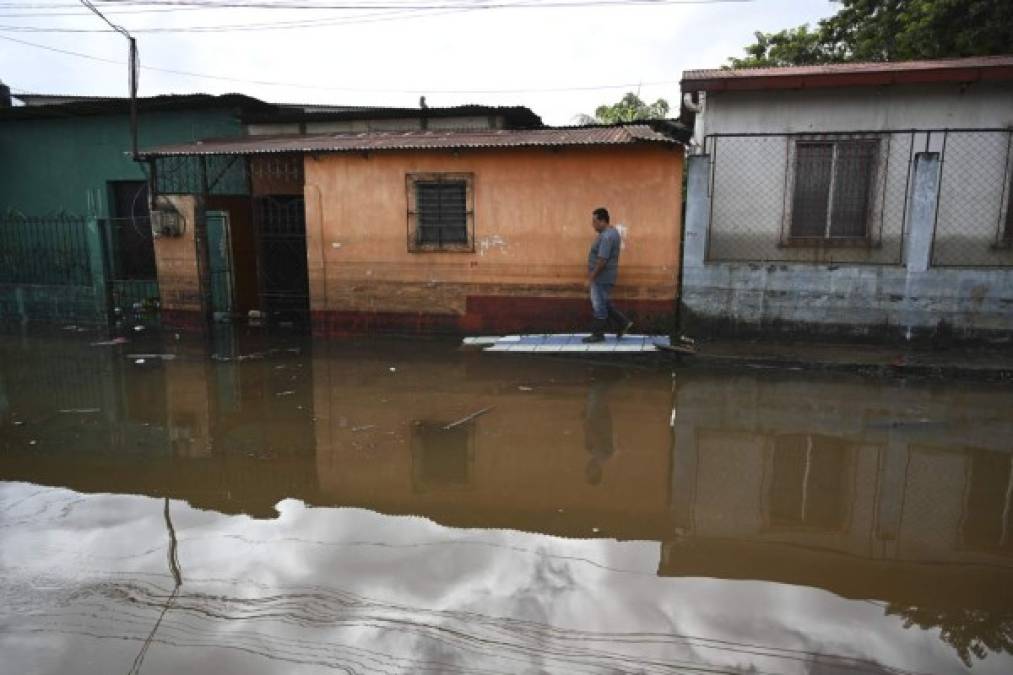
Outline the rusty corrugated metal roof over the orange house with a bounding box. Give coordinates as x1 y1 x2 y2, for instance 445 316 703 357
141 122 688 157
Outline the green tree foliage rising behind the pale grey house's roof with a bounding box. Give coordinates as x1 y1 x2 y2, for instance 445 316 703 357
728 0 1013 68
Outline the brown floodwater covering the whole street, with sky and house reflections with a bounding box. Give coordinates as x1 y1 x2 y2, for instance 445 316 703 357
0 331 1013 675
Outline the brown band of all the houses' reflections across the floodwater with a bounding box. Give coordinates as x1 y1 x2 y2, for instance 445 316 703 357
0 333 1013 661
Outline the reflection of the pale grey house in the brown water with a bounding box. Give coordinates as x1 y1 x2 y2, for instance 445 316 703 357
658 376 1013 667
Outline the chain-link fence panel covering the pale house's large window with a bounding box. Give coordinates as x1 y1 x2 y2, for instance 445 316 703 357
705 132 916 265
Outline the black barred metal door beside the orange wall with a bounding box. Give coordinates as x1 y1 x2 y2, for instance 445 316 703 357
254 196 309 321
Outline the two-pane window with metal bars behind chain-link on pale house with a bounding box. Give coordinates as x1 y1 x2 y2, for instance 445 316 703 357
789 139 879 244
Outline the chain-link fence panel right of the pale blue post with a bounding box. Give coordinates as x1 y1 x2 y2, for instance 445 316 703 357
932 130 1013 267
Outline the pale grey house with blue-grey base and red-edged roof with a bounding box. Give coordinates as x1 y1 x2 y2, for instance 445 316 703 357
682 57 1013 340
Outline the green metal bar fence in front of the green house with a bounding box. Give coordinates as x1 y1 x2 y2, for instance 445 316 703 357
0 216 91 286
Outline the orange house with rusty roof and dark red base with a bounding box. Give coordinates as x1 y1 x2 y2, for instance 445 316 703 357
138 120 686 335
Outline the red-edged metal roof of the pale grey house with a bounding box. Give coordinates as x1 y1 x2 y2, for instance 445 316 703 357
682 56 1013 91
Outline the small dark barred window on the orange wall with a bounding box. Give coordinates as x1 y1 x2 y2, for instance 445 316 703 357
407 173 474 251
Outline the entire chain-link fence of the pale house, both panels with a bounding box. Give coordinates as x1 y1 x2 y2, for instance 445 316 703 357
705 129 1013 267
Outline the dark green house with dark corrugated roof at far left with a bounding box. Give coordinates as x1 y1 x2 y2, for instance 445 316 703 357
0 94 272 323
